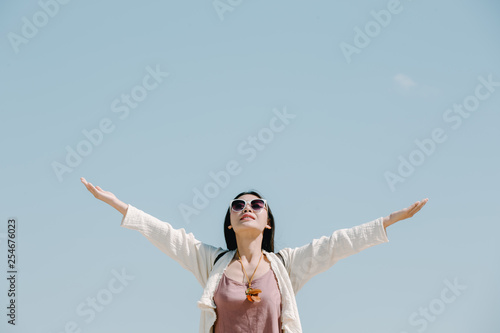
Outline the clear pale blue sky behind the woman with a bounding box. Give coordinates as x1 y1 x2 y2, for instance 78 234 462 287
0 0 500 333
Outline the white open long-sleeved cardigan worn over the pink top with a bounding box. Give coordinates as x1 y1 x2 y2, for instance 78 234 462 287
121 204 389 333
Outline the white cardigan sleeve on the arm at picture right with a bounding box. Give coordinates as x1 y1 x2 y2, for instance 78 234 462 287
280 217 389 294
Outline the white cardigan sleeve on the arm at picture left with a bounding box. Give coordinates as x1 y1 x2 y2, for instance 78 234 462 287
120 204 220 287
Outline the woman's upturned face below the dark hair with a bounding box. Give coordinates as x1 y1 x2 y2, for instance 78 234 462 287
231 194 271 233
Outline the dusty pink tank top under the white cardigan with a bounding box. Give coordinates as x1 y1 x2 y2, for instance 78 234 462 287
214 269 281 333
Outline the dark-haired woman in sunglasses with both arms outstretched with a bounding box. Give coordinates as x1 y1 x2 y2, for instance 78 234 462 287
81 178 428 333
